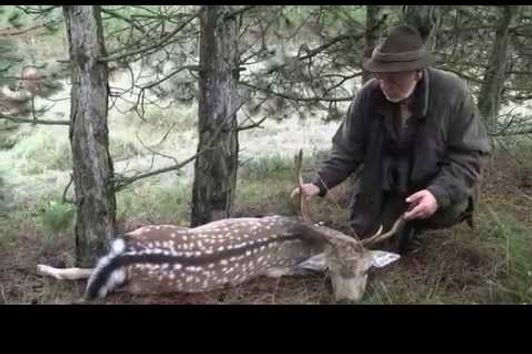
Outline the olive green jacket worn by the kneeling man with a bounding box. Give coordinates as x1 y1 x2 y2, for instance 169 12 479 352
314 68 490 232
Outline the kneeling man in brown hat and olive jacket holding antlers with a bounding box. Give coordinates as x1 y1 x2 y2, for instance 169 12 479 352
294 25 490 255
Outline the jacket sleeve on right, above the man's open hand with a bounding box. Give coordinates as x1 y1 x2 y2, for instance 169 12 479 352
427 90 491 208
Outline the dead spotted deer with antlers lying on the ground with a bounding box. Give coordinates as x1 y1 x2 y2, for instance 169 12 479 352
38 152 403 302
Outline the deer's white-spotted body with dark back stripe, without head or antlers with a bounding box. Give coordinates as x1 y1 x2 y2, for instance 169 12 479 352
87 216 322 298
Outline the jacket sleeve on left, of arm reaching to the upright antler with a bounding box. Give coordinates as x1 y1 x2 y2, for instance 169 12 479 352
313 86 368 197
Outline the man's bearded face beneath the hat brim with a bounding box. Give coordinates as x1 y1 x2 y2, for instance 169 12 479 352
374 71 421 102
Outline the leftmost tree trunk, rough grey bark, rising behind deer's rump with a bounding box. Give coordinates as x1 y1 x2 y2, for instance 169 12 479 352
63 6 116 267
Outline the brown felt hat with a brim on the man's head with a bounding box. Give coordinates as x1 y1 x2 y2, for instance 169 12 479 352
362 25 436 72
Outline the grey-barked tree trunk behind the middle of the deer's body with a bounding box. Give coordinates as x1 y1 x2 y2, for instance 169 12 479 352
191 6 240 226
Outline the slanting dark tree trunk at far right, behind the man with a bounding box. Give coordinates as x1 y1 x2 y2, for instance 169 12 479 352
478 6 517 130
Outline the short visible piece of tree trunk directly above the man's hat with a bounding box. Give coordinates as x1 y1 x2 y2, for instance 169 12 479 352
403 5 439 52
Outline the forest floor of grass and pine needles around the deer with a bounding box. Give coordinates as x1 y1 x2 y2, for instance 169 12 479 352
0 150 532 304
